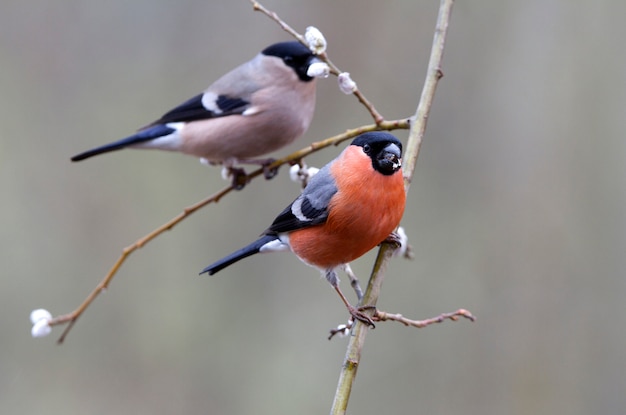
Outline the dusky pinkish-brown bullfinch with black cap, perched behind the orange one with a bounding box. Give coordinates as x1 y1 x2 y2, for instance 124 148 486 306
72 41 321 184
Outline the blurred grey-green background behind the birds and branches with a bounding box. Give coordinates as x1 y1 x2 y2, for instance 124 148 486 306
0 0 626 415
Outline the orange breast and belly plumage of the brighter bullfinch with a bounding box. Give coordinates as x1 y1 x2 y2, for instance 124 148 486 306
289 147 406 269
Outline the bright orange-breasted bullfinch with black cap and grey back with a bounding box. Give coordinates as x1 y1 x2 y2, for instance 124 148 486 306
201 132 406 326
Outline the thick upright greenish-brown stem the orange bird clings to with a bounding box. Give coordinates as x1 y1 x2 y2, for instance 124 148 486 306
330 0 454 415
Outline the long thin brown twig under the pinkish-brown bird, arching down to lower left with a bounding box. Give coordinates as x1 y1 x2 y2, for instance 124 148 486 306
49 119 409 343
